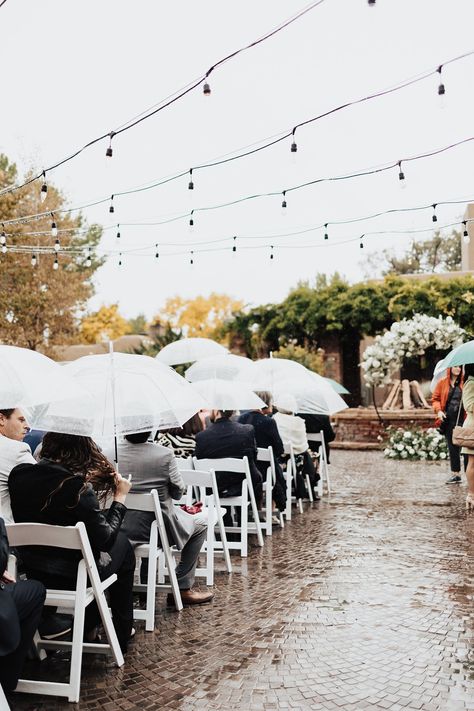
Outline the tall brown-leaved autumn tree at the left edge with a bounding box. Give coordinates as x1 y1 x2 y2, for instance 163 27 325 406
0 155 102 352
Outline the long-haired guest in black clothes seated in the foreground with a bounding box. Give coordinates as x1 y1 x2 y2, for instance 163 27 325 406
8 432 135 652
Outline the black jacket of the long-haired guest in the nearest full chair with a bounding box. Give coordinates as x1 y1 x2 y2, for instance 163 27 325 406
8 459 127 577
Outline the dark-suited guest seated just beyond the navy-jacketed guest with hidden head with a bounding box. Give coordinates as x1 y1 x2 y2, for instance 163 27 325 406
238 390 286 511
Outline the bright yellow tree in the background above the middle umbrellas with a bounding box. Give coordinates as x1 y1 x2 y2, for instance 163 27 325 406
156 292 243 338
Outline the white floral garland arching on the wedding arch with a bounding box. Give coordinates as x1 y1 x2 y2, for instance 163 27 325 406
361 314 466 385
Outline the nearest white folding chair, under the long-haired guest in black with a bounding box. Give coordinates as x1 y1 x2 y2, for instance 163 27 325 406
7 522 123 703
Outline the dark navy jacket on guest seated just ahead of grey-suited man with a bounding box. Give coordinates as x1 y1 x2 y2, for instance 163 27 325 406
194 418 262 499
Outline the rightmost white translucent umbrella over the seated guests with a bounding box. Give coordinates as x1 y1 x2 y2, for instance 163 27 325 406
252 358 347 415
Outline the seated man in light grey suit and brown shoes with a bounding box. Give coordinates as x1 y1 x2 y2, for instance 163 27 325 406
106 432 214 605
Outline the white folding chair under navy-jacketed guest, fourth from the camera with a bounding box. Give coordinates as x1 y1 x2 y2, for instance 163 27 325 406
194 457 263 558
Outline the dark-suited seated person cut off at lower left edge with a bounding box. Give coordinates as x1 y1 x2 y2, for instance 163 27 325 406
0 518 46 692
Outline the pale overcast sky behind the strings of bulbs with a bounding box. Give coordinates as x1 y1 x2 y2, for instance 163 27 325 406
0 0 474 317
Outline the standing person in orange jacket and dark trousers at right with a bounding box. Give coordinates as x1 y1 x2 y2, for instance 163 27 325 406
432 366 466 484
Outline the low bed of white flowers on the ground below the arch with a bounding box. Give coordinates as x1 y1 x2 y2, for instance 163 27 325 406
383 427 448 462
